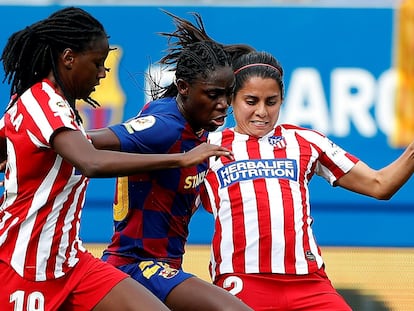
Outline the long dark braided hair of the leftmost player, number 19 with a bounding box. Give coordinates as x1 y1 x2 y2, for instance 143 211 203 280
0 7 107 120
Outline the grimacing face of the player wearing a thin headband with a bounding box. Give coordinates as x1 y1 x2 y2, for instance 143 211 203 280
232 76 282 138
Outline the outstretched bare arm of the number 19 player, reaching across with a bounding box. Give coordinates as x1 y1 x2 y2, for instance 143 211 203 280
52 129 232 177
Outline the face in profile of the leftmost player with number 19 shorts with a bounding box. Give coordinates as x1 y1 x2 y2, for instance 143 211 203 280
60 36 109 99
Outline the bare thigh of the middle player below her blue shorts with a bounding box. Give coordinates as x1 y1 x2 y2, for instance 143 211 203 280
166 277 253 311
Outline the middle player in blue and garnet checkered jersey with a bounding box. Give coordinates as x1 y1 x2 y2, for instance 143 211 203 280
90 10 251 311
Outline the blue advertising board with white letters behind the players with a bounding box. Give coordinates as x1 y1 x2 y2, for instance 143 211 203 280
0 6 414 247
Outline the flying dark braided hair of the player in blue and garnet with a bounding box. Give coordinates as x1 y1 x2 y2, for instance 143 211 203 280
151 11 231 99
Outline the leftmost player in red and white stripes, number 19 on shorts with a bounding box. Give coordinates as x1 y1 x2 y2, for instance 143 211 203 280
0 7 228 311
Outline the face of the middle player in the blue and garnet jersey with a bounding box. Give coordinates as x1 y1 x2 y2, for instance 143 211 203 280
179 67 234 131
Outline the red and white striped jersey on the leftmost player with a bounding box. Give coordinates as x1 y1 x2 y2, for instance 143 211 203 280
0 80 88 281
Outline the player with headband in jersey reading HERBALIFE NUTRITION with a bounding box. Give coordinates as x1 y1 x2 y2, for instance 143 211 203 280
201 52 414 311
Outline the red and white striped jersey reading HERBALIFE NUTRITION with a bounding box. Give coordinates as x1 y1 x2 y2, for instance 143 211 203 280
201 125 358 280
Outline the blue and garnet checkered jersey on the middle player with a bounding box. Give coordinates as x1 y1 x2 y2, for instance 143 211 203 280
102 98 207 268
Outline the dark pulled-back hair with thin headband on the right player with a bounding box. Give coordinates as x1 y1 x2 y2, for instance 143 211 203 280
233 51 284 99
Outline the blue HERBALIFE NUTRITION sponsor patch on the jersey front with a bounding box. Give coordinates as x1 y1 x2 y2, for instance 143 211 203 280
217 159 298 188
